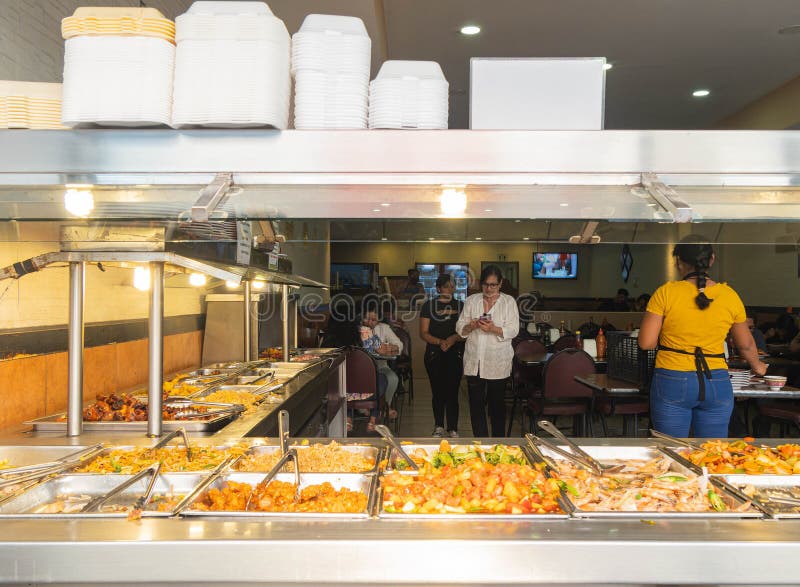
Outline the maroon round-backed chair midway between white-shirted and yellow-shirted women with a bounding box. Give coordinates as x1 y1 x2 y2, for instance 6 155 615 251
528 349 595 436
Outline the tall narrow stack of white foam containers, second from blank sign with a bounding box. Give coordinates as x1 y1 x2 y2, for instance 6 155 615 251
292 14 371 129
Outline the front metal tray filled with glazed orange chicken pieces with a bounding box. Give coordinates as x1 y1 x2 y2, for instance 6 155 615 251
180 473 377 519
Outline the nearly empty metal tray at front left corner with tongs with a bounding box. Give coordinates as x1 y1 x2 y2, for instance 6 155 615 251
0 473 208 519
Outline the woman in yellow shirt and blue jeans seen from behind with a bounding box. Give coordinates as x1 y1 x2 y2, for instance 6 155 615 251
639 235 767 438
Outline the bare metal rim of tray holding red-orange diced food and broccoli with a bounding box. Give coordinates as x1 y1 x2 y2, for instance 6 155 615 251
378 440 572 521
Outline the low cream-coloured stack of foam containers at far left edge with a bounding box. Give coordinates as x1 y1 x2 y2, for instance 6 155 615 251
0 81 64 129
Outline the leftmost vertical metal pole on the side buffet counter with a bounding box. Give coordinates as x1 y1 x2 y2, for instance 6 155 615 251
67 261 86 436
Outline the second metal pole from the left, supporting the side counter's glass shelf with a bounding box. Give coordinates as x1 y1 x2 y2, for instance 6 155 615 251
147 262 164 436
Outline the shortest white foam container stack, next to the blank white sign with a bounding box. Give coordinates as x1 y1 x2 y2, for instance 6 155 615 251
369 61 449 129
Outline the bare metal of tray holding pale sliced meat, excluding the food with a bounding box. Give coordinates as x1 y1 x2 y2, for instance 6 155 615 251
537 445 764 520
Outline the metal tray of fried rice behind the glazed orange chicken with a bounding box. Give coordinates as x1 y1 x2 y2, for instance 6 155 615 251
234 441 381 474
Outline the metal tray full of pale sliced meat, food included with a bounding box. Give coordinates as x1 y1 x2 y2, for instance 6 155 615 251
538 446 763 519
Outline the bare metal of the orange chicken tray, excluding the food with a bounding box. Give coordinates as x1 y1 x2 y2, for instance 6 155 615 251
180 473 377 520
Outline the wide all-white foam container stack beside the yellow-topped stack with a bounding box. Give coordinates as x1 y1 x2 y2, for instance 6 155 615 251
172 1 291 129
